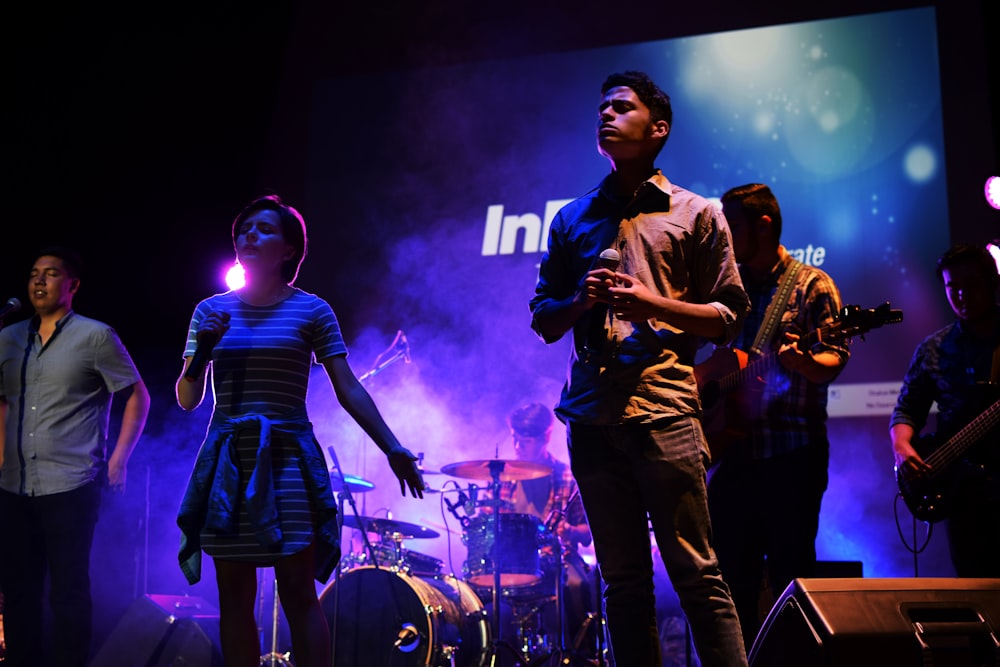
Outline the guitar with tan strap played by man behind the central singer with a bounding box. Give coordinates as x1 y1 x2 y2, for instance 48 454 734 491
694 301 903 461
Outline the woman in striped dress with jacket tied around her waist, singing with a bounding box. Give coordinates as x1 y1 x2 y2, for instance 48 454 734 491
176 196 424 667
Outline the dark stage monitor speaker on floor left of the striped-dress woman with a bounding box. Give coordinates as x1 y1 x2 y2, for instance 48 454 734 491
90 595 223 667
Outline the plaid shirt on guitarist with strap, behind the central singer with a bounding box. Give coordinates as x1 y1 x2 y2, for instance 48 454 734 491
733 247 850 458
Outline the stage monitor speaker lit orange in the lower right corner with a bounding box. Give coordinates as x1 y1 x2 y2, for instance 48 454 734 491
749 578 1000 667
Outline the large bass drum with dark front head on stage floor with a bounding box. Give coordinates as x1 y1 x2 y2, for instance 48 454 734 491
320 566 491 667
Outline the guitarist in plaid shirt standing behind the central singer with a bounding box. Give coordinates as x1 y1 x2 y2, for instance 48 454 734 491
708 183 850 652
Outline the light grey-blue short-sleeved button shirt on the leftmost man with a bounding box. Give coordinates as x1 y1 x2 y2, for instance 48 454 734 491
0 311 140 496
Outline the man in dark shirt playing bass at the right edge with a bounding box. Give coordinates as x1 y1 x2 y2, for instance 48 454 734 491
889 244 1000 578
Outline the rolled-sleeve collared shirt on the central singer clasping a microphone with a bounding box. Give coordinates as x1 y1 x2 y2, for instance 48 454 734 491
529 170 748 424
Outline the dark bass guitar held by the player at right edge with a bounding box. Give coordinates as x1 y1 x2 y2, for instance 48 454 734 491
896 394 1000 523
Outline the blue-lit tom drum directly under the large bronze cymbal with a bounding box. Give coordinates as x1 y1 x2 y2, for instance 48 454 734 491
463 513 545 588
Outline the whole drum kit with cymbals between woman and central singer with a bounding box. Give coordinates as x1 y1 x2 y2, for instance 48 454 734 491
320 459 600 667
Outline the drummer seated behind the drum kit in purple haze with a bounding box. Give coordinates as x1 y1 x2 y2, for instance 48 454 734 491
492 403 596 653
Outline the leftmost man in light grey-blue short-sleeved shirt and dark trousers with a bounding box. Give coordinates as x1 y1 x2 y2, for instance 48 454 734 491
0 247 149 667
